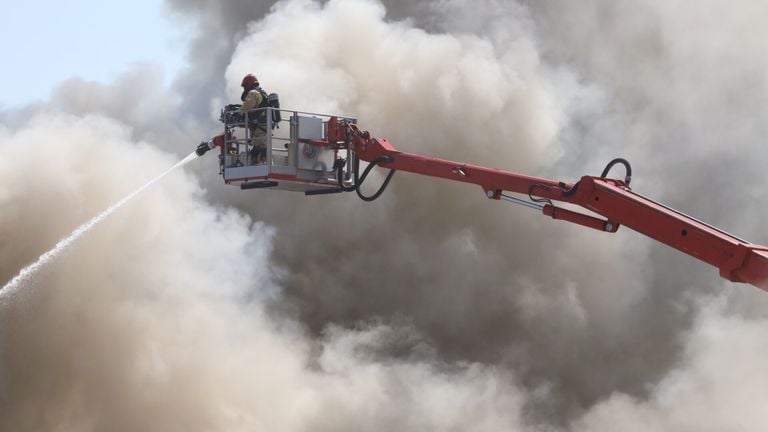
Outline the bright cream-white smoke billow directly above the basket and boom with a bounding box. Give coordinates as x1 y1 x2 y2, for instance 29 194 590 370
226 0 561 168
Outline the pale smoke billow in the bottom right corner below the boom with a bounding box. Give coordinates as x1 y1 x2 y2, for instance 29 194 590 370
574 302 768 432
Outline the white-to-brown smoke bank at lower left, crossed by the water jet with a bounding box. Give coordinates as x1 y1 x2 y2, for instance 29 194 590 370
0 112 536 431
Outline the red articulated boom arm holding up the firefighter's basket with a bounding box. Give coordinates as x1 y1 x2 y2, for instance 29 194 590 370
346 125 768 291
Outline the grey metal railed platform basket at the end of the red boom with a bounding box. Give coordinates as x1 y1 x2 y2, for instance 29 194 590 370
220 105 356 195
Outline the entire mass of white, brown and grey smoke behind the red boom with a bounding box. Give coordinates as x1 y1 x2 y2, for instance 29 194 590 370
0 0 768 431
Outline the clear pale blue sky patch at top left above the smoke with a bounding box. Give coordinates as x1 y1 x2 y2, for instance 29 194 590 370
0 0 185 109
